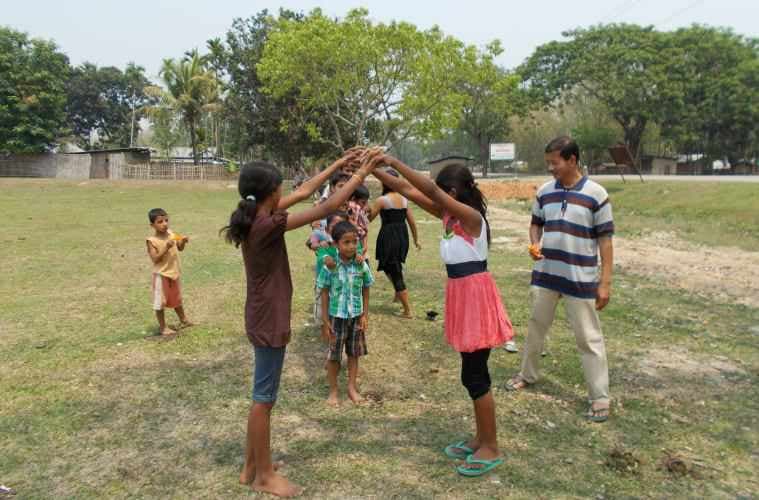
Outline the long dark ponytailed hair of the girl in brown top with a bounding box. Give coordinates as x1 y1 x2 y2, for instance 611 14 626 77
220 161 282 247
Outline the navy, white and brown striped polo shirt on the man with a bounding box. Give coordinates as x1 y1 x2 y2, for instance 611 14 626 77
532 177 614 299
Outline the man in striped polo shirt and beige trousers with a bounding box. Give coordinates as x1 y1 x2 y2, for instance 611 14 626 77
507 137 614 422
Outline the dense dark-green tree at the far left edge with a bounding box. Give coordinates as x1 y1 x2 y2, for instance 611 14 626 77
0 26 71 153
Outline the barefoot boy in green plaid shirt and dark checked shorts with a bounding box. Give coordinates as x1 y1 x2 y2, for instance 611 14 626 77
317 221 374 406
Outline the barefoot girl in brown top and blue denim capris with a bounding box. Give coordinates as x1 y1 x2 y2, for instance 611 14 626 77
222 149 380 497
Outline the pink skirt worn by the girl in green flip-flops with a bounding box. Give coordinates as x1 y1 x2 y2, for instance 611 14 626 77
445 272 514 352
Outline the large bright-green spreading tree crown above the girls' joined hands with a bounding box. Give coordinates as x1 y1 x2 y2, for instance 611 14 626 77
257 9 461 149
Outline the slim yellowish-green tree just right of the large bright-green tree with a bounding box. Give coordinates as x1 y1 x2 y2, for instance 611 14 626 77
456 41 526 177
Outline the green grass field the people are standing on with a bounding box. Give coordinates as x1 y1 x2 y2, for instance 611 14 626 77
0 179 759 499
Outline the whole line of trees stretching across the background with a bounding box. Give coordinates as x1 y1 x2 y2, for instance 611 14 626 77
0 14 759 169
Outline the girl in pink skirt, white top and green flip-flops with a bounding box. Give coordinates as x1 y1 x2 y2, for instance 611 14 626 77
372 155 514 476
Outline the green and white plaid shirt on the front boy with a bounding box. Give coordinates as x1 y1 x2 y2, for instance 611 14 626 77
316 258 374 319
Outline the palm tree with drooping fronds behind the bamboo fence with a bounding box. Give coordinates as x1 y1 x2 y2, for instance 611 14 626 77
161 50 219 165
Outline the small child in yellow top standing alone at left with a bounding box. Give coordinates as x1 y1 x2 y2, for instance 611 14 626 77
145 208 192 335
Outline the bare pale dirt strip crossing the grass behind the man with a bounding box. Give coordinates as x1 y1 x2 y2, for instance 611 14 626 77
489 207 759 307
